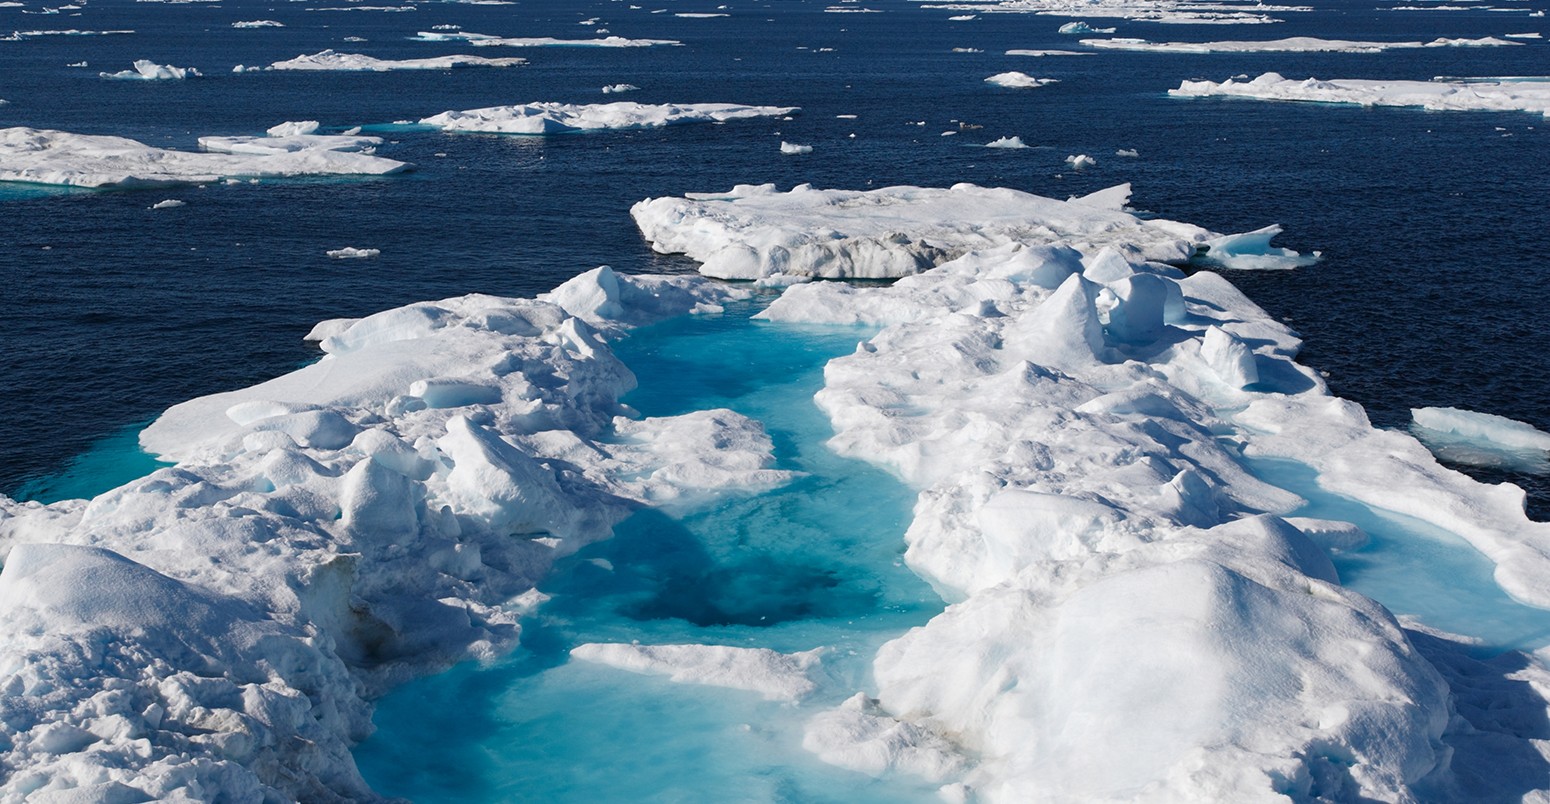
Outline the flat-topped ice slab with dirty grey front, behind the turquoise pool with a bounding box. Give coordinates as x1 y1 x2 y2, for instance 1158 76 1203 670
629 184 1295 279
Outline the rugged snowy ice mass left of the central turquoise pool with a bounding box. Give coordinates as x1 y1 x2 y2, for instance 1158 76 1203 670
0 270 775 801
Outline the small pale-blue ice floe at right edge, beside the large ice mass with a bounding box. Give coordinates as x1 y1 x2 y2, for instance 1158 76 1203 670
1411 407 1550 474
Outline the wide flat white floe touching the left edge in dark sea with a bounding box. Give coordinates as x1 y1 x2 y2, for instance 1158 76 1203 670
0 127 409 187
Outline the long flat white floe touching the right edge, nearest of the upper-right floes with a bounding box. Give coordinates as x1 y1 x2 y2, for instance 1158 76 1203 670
1169 73 1550 116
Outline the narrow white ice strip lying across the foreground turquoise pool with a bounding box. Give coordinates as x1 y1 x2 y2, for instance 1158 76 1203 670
570 643 825 700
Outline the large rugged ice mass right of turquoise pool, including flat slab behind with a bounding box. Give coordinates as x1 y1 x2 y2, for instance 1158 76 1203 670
636 179 1550 801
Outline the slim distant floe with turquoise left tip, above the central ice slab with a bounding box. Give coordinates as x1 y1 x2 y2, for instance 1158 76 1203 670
420 101 797 135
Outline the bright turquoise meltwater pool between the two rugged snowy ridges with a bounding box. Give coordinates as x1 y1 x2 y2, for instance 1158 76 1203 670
355 305 942 802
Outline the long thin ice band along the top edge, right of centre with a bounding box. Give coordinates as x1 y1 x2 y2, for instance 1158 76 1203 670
921 0 1311 24
